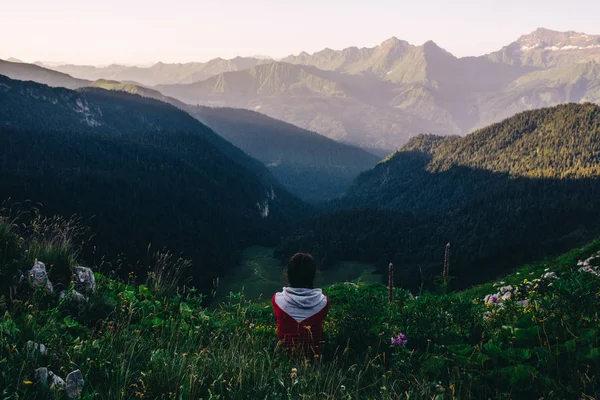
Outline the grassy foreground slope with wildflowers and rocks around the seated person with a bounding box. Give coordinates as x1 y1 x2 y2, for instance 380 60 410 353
0 211 600 399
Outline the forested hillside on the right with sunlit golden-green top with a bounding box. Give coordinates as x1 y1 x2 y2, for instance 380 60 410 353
278 104 600 287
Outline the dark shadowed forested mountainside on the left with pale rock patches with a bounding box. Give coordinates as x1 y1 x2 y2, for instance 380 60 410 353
0 77 304 284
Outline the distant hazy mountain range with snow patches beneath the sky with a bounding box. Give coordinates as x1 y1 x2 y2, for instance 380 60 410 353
8 28 600 150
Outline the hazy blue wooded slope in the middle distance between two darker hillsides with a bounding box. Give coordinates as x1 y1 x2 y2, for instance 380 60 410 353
186 106 379 202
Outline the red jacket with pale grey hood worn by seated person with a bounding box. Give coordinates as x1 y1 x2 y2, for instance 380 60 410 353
271 287 329 357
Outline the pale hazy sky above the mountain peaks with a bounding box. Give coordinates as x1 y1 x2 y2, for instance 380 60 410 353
0 0 600 64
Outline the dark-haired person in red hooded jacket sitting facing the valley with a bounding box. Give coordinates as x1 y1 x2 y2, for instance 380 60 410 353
271 253 329 358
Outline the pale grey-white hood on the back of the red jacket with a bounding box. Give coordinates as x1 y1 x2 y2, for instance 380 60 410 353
275 287 327 322
